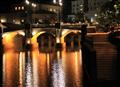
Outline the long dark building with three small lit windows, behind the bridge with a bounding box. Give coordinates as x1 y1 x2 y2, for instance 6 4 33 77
0 3 59 24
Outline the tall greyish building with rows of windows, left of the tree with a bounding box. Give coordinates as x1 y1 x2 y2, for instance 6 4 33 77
71 0 108 22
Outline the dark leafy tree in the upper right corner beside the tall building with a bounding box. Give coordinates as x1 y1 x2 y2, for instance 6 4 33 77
98 0 120 25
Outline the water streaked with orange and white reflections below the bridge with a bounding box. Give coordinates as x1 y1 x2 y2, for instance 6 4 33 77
3 49 83 87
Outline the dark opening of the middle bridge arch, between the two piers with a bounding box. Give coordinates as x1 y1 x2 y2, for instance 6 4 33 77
37 32 56 52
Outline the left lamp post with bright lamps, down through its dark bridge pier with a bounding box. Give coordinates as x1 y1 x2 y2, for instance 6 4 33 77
25 0 37 50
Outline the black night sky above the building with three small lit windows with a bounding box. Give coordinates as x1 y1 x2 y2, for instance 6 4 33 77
0 0 52 12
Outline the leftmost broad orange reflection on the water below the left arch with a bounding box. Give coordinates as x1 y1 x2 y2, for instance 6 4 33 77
3 50 19 87
